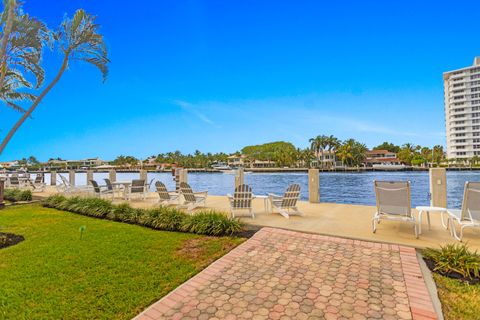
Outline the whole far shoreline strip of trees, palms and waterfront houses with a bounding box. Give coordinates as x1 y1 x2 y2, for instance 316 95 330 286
0 135 464 172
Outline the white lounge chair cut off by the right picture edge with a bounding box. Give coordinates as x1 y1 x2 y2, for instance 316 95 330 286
447 181 480 241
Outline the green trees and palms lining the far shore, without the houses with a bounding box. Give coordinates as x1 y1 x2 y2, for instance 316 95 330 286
108 135 446 168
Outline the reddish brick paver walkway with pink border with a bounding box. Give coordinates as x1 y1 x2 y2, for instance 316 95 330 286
137 228 437 320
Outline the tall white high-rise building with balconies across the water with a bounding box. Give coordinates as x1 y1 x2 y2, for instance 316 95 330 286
443 57 480 159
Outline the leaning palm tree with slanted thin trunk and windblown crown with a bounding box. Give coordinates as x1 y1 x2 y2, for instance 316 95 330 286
0 9 109 154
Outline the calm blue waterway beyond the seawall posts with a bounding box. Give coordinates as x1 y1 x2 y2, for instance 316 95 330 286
46 171 480 208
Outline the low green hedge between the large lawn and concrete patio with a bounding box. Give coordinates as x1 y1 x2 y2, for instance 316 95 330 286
43 195 243 236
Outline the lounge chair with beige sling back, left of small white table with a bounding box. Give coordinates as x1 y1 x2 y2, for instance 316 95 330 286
372 181 418 238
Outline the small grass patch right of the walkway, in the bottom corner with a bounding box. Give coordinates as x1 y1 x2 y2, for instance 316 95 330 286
433 273 480 320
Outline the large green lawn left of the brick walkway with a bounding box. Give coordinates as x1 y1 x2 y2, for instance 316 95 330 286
0 205 243 319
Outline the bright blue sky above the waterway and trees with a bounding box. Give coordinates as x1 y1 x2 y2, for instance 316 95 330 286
0 0 480 160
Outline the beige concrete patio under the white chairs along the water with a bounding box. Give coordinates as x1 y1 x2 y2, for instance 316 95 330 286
122 193 480 250
